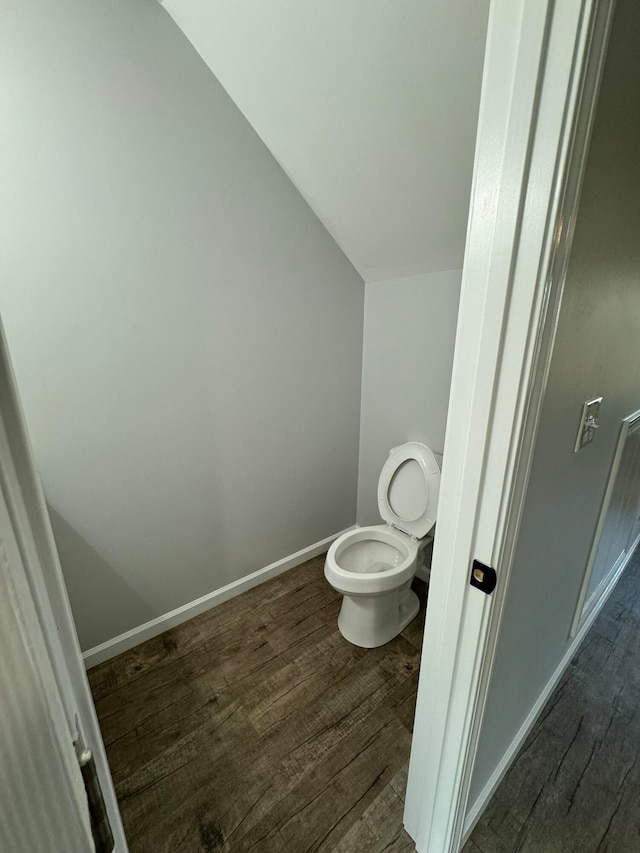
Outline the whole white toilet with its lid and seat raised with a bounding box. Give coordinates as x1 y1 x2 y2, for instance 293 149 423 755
324 441 440 649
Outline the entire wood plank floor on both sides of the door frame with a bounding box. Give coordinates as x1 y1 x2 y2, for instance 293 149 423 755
89 554 640 853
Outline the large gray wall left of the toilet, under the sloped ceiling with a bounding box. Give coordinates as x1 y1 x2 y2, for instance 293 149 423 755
0 0 363 649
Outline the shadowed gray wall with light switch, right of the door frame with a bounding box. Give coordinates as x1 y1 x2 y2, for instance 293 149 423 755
470 0 640 804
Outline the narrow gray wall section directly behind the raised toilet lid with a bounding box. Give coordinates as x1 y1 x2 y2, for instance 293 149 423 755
358 270 461 525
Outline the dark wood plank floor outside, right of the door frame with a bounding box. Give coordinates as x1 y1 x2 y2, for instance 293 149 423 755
464 552 640 853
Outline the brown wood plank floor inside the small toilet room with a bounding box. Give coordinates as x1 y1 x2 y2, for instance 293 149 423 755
89 556 425 853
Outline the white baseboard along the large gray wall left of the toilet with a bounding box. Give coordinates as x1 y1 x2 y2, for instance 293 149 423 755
82 527 354 669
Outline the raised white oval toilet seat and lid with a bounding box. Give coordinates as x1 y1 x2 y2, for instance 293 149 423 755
378 441 440 539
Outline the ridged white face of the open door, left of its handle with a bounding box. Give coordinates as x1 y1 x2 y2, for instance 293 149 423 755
0 452 94 853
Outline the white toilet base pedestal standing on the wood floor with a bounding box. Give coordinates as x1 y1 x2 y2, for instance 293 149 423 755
338 582 420 649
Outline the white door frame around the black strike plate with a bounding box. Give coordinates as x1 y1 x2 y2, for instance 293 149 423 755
405 0 615 853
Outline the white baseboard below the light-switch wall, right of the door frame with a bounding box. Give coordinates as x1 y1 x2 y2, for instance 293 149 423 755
462 539 640 845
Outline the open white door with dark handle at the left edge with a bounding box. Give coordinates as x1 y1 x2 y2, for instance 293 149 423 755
0 322 127 853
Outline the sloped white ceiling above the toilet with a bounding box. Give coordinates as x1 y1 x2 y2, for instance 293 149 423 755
164 0 489 281
